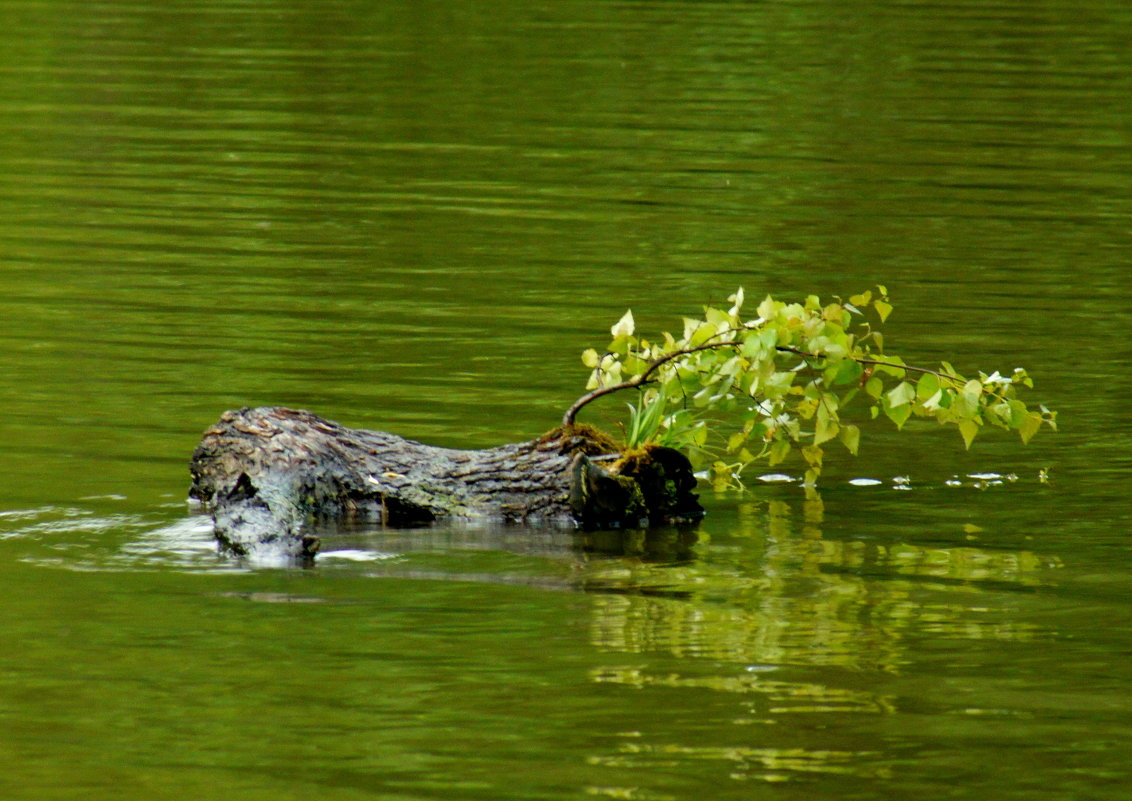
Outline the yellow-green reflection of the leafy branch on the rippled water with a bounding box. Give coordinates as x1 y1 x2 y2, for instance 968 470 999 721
586 501 1057 680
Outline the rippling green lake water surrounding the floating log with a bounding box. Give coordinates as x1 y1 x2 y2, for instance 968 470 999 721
0 0 1132 801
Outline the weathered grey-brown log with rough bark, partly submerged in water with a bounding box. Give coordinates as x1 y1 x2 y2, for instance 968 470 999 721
189 407 703 557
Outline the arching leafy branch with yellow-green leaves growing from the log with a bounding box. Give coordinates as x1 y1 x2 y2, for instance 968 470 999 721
563 286 1056 484
